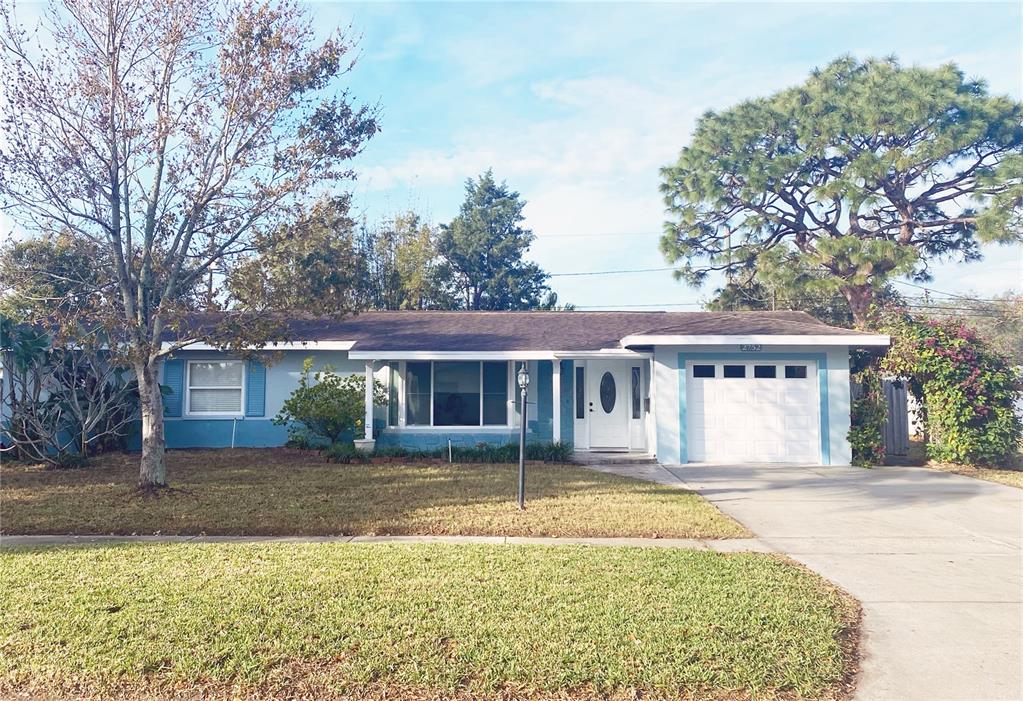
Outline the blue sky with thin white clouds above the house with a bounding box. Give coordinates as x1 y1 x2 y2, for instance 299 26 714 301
325 2 1023 309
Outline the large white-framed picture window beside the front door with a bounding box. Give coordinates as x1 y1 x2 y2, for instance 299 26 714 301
401 360 509 427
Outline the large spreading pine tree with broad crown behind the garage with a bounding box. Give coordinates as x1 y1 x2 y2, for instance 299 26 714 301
661 58 1023 324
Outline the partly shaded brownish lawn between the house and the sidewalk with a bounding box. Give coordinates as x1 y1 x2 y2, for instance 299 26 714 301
0 448 749 538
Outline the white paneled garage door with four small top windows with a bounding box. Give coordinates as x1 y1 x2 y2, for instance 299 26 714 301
685 361 820 464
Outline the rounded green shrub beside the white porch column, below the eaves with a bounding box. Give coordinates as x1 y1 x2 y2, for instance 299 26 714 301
273 358 387 445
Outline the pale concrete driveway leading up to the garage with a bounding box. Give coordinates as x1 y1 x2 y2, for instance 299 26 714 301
589 466 1023 701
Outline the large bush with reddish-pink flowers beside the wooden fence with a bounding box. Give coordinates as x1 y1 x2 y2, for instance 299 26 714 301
882 314 1023 465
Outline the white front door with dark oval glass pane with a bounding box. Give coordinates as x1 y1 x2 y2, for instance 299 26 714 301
586 361 630 450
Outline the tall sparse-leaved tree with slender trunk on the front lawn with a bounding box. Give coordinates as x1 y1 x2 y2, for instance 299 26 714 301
0 0 377 489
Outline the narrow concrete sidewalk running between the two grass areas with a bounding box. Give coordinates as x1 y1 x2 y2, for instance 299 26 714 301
0 535 770 553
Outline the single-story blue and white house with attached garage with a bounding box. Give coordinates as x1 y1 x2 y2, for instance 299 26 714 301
161 311 889 465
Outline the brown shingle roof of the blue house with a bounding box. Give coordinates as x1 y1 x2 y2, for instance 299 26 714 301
173 311 858 351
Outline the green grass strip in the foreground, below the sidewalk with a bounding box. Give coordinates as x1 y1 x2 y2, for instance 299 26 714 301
0 543 858 700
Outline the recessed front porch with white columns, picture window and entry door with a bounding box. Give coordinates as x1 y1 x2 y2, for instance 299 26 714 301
351 349 655 459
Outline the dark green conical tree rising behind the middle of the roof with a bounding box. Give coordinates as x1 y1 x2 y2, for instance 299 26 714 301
438 170 558 309
